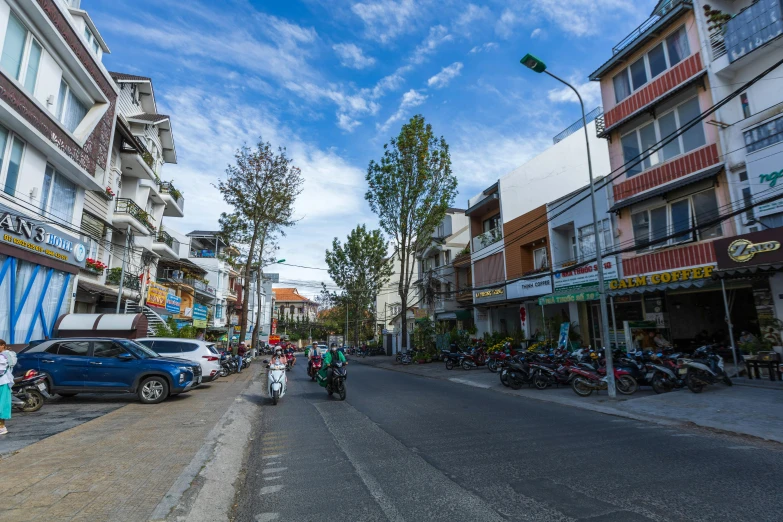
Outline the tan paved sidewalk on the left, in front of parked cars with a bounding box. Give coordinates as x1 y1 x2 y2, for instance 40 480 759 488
0 364 261 522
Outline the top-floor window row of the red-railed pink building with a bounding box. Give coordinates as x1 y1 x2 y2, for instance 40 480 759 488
612 26 691 103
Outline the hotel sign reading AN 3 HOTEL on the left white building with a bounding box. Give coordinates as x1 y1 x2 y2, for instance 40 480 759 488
0 200 87 268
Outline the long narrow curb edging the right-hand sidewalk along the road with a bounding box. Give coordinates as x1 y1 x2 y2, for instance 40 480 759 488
357 361 783 444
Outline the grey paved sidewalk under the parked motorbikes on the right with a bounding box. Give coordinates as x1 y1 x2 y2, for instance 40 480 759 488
351 357 783 443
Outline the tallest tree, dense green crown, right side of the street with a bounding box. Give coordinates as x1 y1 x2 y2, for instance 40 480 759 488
365 115 457 347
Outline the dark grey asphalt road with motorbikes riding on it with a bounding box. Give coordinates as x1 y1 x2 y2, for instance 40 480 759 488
233 358 783 522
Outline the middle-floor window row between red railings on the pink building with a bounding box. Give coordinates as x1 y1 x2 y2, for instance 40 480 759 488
620 97 707 177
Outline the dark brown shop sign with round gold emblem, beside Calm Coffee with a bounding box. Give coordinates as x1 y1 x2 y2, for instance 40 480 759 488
713 228 783 270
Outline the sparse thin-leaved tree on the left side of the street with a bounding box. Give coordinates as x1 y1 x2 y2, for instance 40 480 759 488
217 141 304 352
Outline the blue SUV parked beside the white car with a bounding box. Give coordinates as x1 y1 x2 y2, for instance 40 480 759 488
14 337 201 404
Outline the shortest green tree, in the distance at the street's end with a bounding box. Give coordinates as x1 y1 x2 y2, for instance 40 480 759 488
326 225 392 344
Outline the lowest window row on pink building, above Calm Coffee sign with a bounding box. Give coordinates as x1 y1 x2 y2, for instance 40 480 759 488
631 189 723 250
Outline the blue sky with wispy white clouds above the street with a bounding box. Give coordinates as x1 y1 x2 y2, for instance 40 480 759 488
89 0 656 294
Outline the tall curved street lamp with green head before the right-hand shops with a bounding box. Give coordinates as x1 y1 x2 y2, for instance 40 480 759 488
520 53 616 399
